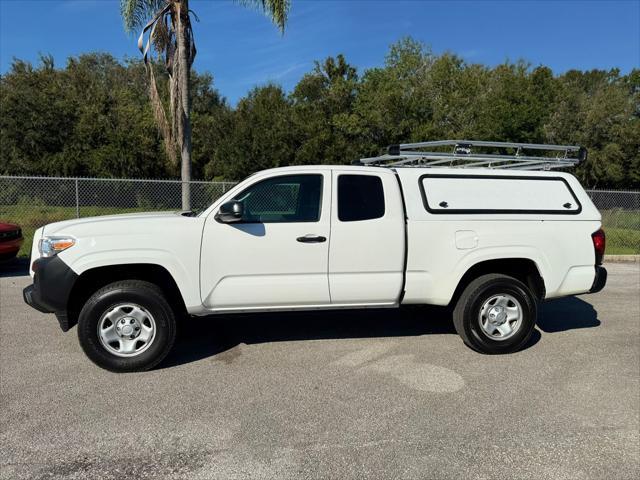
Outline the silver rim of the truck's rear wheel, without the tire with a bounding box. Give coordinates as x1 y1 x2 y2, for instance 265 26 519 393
478 293 522 341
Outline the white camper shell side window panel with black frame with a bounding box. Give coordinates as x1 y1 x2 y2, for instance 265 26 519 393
418 174 582 215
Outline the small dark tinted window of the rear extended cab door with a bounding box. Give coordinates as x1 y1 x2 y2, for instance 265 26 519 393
338 175 384 222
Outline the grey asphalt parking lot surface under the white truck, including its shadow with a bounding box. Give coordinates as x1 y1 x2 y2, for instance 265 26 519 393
0 264 640 479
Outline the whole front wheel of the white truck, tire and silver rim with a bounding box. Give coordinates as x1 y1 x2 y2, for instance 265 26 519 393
78 280 176 372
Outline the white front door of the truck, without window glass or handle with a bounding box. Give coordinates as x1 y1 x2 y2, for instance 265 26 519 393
200 169 331 311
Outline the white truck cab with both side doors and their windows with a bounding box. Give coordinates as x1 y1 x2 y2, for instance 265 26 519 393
200 167 405 312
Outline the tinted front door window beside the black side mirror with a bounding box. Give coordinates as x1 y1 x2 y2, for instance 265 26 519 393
234 174 322 223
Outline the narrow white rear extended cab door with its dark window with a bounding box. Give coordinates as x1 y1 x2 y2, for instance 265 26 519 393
329 168 405 305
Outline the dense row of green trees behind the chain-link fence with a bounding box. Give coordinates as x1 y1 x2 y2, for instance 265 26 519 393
0 38 640 189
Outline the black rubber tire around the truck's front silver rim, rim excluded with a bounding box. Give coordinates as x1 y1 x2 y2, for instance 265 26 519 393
78 280 176 372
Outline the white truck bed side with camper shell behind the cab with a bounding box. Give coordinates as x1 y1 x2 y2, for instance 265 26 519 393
398 168 601 305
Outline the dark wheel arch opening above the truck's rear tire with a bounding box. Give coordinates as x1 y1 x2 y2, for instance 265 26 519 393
450 257 546 305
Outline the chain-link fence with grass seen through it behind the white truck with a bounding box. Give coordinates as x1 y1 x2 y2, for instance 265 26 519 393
0 176 640 256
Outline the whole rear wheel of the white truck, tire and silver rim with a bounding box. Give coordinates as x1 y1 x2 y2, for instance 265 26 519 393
453 274 537 354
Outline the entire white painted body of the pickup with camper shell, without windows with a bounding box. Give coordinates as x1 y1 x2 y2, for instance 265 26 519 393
32 166 600 315
